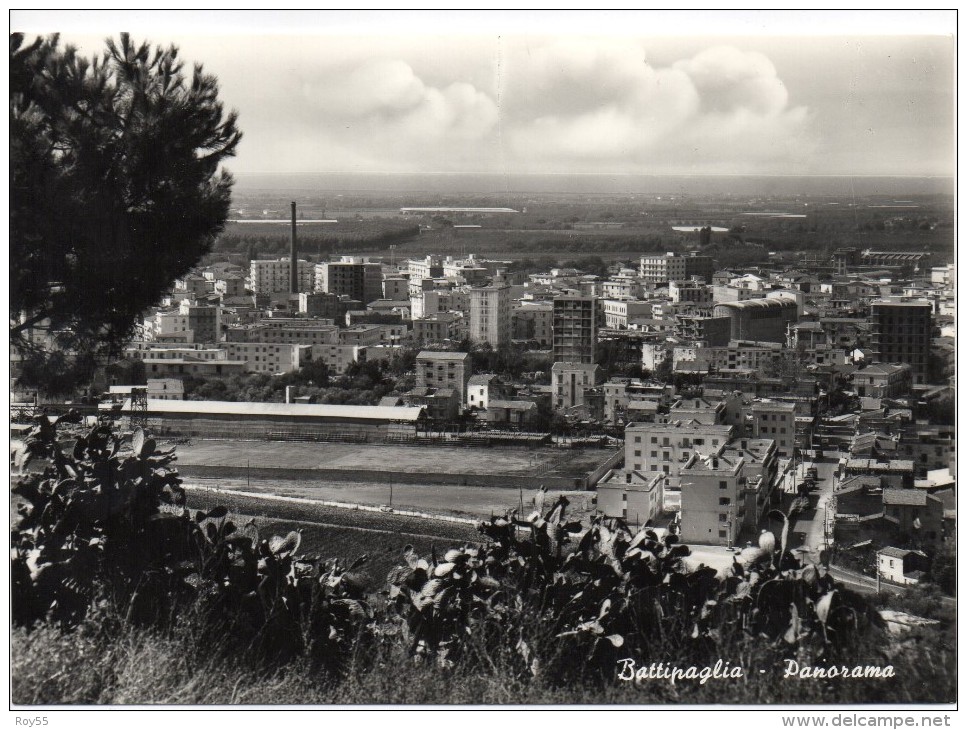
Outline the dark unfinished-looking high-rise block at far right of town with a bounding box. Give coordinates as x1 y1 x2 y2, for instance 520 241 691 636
870 298 933 384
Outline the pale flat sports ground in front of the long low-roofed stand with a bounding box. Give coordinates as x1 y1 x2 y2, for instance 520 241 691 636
178 441 611 477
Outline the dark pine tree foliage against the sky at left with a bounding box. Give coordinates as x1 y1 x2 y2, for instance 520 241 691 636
10 34 241 387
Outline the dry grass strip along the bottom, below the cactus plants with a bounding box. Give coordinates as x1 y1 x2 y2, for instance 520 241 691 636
11 620 957 706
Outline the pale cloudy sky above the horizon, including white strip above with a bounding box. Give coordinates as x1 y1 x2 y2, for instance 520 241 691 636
12 11 956 180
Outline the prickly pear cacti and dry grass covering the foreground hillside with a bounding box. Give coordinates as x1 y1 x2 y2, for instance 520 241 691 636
12 417 955 704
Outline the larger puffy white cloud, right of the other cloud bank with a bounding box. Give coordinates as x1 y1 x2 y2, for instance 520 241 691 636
508 42 814 172
